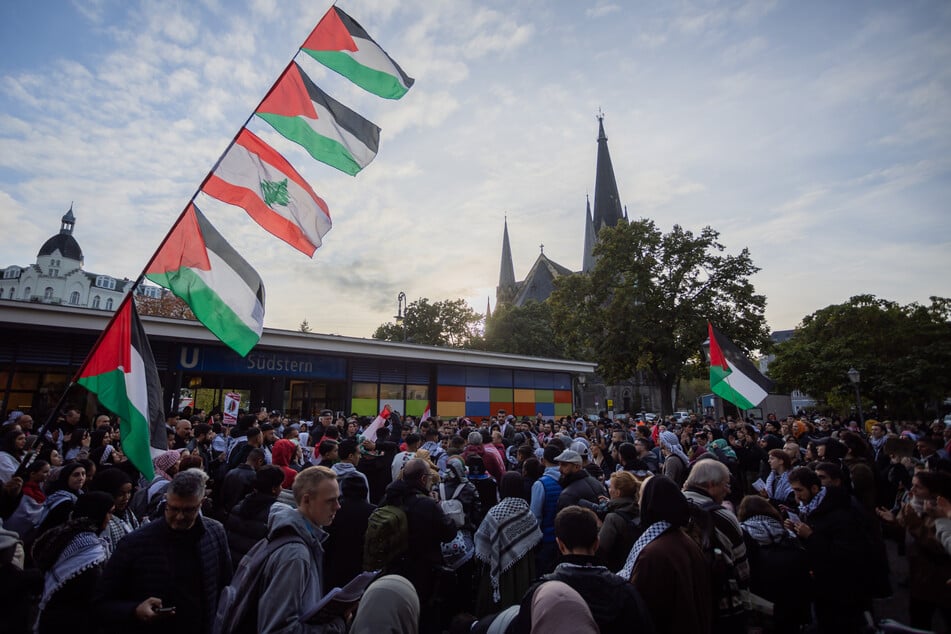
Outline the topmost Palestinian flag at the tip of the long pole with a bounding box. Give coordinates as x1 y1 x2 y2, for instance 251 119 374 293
301 7 416 99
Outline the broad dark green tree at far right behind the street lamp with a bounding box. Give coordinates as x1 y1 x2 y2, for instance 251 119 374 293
769 295 951 415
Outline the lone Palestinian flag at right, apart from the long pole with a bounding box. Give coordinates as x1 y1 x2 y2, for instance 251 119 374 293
707 322 773 409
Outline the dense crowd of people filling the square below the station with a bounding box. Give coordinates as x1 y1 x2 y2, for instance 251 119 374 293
0 408 951 634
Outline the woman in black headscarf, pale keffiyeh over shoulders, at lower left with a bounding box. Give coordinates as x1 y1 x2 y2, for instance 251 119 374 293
33 491 113 634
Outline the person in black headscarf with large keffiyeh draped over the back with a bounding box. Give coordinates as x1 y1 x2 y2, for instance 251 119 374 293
474 470 542 616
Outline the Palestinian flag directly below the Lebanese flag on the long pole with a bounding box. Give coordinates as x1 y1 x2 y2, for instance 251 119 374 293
145 204 264 357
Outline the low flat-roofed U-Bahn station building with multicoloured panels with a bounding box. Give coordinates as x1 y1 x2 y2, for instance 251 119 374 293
0 299 594 420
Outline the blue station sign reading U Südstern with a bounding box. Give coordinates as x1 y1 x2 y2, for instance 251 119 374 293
176 346 347 380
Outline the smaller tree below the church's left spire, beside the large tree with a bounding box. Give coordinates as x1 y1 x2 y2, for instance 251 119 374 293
485 301 564 359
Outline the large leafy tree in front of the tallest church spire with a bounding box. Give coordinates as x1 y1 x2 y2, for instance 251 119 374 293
550 219 769 414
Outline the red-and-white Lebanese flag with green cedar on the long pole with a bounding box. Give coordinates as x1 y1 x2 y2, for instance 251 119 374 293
202 128 332 257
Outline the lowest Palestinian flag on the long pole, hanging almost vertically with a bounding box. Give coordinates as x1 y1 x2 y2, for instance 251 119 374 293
76 298 168 480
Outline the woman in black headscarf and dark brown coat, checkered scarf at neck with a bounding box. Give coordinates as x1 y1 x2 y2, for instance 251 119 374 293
618 476 713 634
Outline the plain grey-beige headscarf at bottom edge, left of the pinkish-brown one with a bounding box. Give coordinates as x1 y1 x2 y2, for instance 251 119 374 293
350 575 419 634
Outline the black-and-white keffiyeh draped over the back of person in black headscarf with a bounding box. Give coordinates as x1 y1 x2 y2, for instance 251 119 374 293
475 497 542 603
